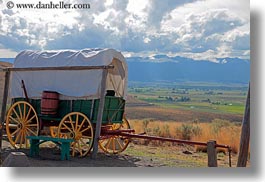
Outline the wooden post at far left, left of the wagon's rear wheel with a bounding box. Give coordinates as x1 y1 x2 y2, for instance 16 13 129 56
0 71 10 154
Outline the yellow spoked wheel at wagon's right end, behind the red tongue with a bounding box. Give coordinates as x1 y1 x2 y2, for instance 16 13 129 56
99 117 131 154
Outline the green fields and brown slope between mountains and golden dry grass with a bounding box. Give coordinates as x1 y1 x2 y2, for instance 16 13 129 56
126 83 248 122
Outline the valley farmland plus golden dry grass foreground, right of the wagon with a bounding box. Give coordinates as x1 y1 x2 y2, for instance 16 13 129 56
123 83 248 161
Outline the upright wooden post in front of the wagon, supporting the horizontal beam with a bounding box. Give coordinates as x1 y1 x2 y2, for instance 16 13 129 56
91 69 108 159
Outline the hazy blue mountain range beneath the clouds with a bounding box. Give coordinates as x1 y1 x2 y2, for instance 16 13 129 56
0 55 250 84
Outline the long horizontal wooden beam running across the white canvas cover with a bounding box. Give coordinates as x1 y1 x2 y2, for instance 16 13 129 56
2 65 114 72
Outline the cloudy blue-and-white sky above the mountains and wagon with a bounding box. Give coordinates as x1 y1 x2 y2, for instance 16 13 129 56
0 0 250 62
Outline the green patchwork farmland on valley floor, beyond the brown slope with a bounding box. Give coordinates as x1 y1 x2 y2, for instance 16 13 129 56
129 83 247 114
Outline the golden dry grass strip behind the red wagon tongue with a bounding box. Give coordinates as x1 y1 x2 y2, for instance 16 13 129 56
130 119 241 153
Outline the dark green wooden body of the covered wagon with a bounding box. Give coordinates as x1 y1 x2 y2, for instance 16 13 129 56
13 96 125 125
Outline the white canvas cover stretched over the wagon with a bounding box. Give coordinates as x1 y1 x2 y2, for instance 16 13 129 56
11 49 127 100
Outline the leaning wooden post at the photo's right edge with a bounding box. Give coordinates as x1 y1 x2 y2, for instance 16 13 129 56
237 85 250 167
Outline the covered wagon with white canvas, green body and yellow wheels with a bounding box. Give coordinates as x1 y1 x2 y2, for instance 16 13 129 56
2 49 130 156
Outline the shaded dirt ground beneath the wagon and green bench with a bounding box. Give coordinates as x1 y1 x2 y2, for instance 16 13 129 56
1 140 165 167
